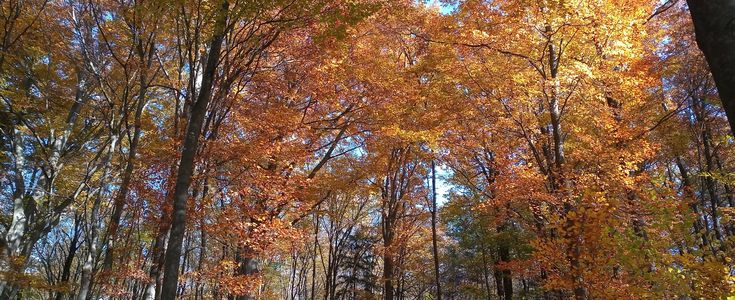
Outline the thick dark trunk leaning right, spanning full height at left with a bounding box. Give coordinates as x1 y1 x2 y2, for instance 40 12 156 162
161 1 229 300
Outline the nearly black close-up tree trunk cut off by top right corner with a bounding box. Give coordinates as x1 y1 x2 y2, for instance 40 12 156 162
687 0 735 132
